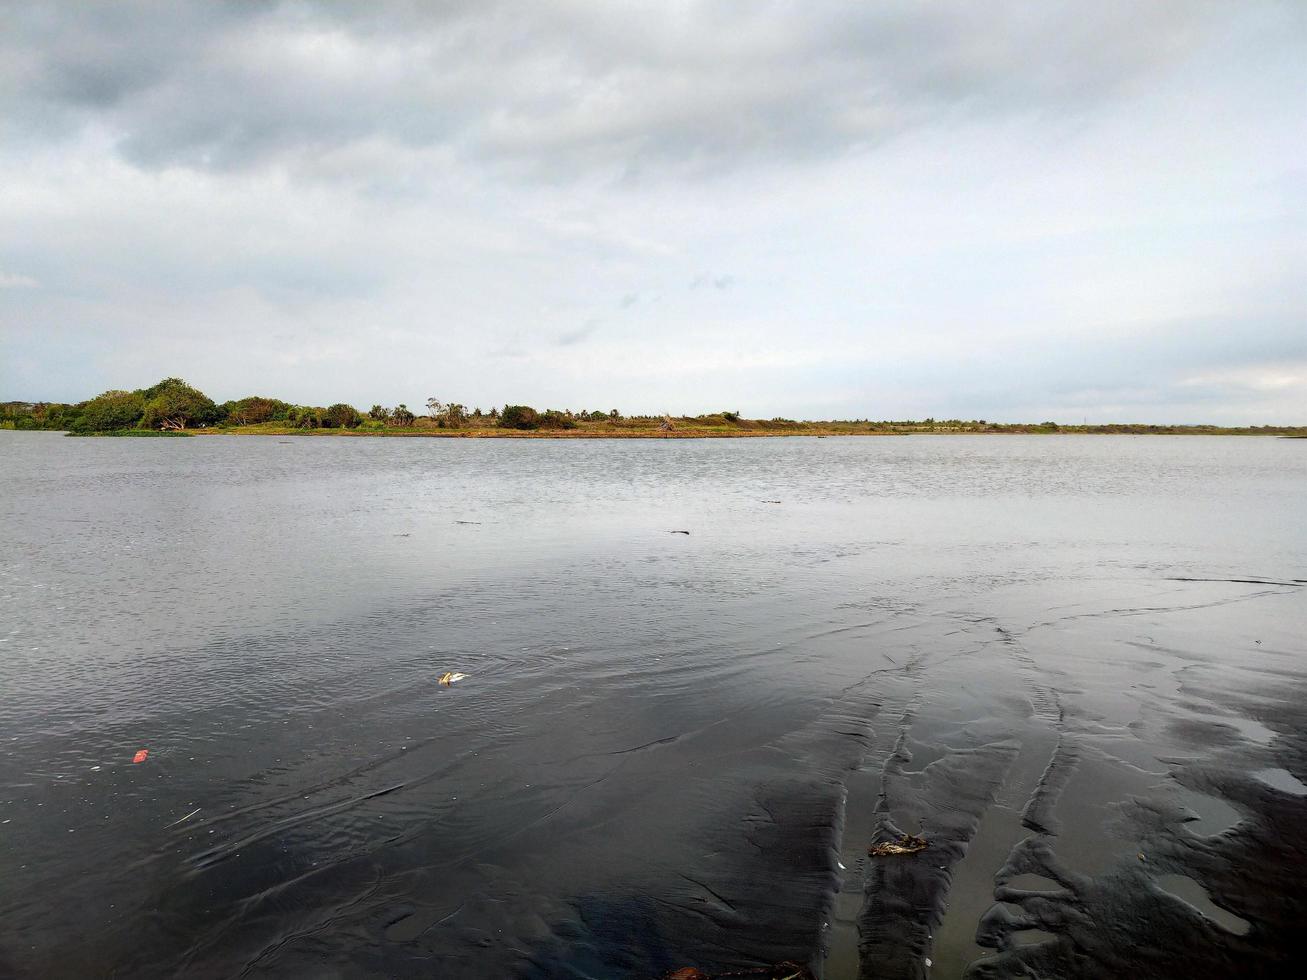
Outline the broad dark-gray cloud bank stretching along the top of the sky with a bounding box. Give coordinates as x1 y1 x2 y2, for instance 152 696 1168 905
0 0 1265 179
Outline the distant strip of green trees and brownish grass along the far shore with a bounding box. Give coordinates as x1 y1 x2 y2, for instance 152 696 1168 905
0 378 1307 438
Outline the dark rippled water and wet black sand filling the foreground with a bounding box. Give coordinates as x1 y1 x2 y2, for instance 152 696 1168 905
0 433 1307 980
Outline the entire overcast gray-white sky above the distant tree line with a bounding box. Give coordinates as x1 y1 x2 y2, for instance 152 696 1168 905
0 0 1307 425
